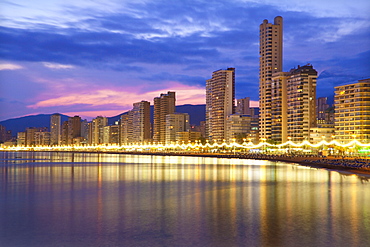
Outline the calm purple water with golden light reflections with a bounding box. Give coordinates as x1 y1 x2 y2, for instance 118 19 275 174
0 152 370 247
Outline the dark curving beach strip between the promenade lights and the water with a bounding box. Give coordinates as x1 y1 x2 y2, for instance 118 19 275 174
2 150 370 176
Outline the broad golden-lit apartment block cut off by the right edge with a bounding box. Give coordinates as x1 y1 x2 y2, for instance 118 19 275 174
334 79 370 143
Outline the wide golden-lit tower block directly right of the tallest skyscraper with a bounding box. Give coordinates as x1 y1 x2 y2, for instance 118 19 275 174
270 64 317 143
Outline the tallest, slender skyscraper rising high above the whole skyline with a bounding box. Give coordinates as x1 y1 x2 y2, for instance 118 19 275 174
259 16 283 139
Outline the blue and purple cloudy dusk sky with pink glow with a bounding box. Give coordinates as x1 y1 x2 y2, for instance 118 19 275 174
0 0 370 121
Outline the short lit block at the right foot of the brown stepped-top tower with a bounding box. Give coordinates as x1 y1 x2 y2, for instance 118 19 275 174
165 112 190 144
